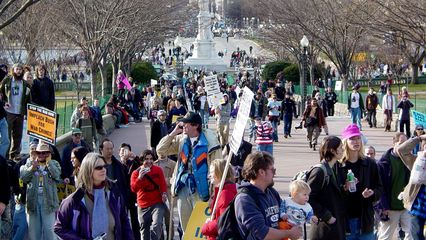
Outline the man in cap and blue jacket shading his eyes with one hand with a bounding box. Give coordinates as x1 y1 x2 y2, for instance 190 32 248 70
157 112 222 234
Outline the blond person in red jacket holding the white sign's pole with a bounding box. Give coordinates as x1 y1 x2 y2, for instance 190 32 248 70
201 159 237 240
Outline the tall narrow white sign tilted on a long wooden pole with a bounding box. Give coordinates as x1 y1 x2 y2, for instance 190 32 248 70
229 87 254 155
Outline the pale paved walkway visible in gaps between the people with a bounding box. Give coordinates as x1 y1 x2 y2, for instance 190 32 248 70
109 116 394 194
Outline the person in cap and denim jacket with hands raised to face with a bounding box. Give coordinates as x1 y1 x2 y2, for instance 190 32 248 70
20 142 61 240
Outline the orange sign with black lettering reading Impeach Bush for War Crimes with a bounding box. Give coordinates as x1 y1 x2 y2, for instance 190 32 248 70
27 104 56 144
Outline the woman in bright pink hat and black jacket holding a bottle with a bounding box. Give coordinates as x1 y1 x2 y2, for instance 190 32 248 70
338 124 383 240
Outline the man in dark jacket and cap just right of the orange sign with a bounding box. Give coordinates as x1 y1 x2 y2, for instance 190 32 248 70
61 128 90 184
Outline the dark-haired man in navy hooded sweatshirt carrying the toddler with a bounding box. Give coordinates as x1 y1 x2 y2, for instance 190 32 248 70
235 152 302 239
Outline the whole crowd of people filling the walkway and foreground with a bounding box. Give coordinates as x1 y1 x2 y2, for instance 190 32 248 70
0 57 426 239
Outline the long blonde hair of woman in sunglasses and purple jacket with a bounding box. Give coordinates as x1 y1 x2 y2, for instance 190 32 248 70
77 153 106 193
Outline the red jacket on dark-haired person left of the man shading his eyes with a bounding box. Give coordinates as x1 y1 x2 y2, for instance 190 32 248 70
130 166 167 208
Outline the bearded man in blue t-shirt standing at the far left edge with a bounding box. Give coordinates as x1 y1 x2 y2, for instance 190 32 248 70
0 64 31 159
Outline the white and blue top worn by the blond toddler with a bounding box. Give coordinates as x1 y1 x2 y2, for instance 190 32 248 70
280 197 314 226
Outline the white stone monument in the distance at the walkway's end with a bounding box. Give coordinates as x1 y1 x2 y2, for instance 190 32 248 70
185 0 226 72
